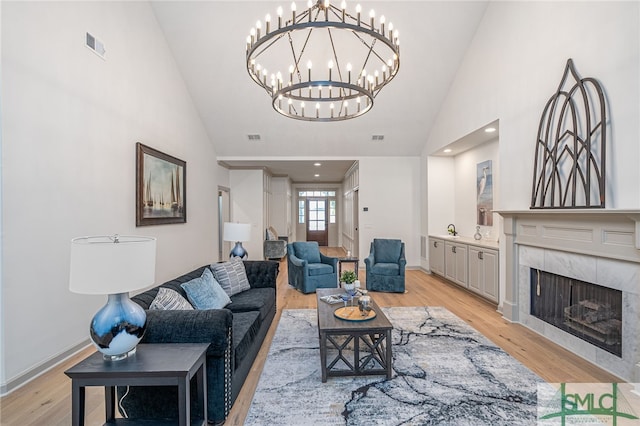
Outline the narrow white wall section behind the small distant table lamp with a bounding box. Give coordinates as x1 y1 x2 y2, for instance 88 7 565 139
229 170 266 260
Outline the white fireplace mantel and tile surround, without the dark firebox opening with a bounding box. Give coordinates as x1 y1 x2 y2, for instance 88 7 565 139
495 209 640 380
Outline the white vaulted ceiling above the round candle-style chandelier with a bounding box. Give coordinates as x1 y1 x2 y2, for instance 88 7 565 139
151 0 488 181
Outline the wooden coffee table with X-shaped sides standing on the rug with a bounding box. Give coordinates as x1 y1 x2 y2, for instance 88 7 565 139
316 288 393 383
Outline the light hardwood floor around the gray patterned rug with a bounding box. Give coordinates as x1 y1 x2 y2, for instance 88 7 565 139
0 248 622 426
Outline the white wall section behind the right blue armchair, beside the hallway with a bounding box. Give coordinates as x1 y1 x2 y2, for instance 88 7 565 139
358 157 420 267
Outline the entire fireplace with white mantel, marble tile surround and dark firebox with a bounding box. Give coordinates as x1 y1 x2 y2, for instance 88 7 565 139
499 209 640 383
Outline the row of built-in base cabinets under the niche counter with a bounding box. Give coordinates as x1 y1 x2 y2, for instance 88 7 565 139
429 237 500 303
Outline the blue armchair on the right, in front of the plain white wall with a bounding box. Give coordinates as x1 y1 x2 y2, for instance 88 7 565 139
364 238 407 293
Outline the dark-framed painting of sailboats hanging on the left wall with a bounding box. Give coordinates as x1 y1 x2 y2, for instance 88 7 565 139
136 142 187 226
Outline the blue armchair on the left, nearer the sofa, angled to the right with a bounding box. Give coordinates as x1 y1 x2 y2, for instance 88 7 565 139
287 241 338 294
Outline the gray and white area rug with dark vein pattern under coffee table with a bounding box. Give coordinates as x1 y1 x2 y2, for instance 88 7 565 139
245 307 542 426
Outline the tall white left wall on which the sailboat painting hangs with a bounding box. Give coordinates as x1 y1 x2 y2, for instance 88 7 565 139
0 2 224 392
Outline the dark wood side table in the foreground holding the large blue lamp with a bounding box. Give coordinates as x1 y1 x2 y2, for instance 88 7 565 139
65 343 209 426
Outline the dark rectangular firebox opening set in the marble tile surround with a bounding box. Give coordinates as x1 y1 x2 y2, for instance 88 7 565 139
529 268 622 357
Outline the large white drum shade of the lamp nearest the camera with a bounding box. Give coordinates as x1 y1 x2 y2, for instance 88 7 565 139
69 236 156 294
